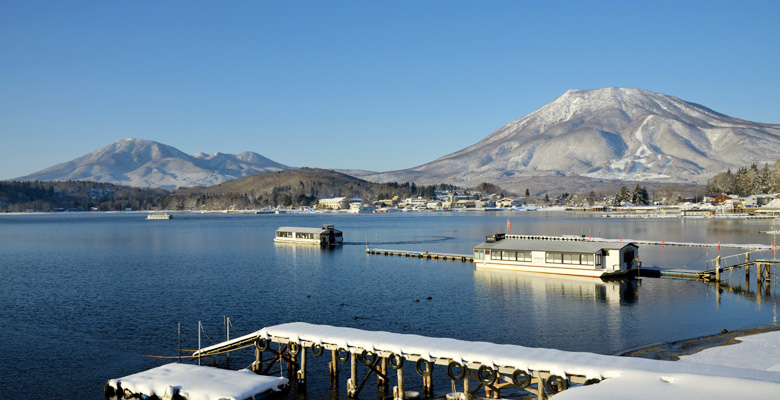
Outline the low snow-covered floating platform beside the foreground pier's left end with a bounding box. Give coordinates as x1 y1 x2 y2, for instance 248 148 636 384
108 363 287 400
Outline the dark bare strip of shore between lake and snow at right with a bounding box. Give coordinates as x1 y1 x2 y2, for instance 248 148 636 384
615 324 780 361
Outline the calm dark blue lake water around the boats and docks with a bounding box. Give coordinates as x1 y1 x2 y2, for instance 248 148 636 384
0 212 778 400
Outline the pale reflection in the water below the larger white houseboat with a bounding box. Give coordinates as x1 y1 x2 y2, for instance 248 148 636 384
474 268 637 306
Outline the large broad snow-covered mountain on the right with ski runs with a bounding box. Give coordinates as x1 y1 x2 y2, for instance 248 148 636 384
362 88 780 189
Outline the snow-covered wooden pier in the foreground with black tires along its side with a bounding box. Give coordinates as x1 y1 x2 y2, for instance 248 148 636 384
193 322 780 400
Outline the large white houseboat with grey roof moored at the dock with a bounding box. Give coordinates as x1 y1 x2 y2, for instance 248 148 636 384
474 233 640 278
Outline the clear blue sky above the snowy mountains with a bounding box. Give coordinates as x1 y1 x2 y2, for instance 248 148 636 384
0 0 780 179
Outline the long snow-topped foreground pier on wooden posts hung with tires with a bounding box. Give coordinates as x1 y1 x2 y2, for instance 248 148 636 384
194 322 780 399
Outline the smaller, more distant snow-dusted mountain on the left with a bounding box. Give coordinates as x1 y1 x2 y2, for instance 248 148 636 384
14 139 290 189
